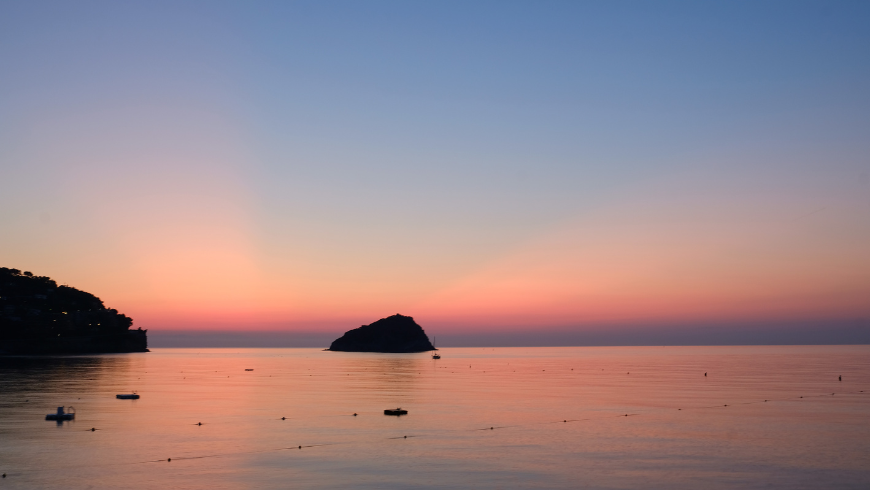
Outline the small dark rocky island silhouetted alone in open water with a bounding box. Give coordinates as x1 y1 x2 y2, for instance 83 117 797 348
328 314 435 352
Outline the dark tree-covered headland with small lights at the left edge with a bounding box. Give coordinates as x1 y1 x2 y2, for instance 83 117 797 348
0 267 148 355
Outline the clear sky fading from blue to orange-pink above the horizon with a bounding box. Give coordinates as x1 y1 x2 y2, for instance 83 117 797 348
0 0 870 343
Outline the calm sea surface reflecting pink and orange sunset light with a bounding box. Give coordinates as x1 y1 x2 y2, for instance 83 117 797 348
0 346 870 489
